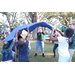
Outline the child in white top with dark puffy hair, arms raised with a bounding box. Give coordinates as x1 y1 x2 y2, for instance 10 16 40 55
50 28 74 62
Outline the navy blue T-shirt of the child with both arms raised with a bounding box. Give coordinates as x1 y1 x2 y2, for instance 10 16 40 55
16 41 29 62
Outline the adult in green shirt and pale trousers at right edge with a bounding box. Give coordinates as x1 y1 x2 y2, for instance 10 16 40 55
69 22 75 62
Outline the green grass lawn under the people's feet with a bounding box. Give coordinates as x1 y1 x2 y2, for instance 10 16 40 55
0 41 75 62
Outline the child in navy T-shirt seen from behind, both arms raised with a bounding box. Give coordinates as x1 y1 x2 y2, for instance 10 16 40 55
16 27 29 62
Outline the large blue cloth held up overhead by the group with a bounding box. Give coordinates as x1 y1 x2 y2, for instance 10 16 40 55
5 22 54 41
